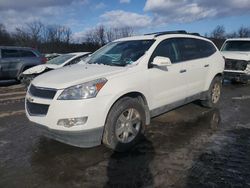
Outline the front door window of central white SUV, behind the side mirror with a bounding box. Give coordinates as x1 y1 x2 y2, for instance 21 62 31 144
149 39 180 63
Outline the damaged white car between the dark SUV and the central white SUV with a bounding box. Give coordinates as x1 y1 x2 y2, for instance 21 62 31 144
20 52 90 87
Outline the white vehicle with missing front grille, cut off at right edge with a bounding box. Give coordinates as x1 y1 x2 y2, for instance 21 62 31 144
221 38 250 83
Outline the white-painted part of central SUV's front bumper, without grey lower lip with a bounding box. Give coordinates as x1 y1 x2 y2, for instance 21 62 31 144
25 92 110 132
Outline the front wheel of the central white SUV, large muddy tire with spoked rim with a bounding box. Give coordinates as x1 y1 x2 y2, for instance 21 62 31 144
102 97 146 152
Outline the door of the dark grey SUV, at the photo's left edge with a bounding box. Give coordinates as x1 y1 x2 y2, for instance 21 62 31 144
0 49 20 79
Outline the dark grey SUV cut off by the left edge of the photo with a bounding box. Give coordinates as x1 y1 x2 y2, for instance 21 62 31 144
0 46 46 80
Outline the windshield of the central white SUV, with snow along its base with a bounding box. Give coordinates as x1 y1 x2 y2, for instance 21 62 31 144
86 40 154 66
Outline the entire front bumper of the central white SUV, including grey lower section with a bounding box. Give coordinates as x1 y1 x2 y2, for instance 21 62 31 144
25 86 112 147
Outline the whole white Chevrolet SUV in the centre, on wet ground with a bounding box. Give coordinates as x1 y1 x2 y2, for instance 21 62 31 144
25 32 224 151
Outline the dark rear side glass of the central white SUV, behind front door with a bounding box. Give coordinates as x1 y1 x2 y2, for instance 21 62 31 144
177 38 216 61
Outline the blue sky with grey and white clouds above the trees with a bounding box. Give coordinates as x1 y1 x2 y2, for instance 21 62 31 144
0 0 250 40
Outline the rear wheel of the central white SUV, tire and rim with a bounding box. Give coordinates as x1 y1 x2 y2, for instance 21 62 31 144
201 76 222 108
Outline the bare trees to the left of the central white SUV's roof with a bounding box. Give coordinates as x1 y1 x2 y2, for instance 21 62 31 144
0 21 134 53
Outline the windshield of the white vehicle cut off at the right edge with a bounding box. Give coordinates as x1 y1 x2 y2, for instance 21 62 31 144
221 41 250 52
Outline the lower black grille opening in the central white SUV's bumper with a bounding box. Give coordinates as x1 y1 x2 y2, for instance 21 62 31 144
26 101 49 116
